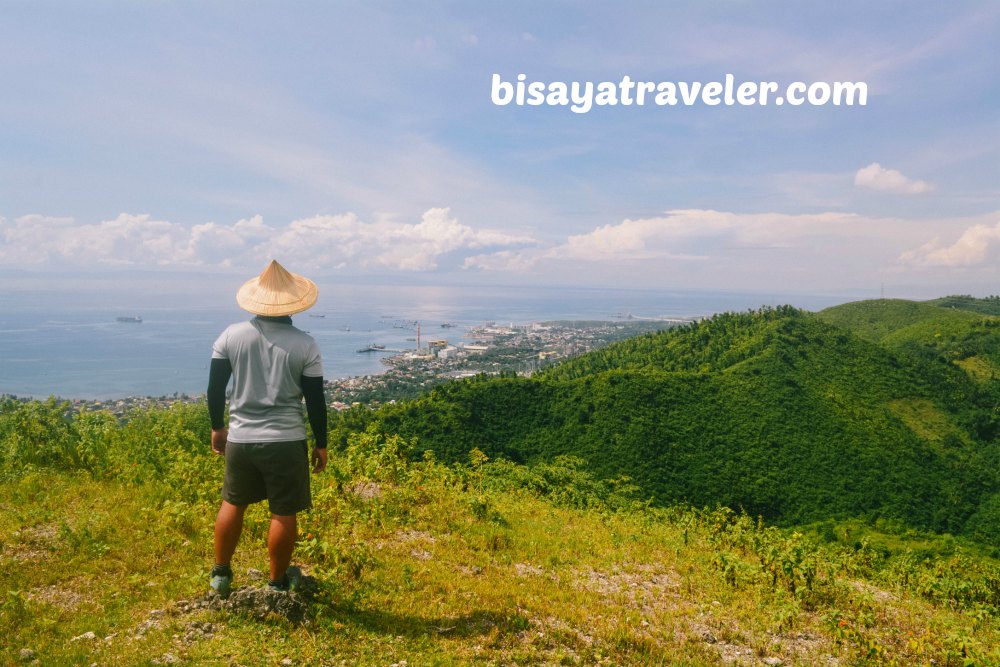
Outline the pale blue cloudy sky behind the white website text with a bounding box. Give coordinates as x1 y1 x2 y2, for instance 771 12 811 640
0 0 1000 297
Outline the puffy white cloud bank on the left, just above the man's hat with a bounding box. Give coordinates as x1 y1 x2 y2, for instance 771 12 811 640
0 208 535 271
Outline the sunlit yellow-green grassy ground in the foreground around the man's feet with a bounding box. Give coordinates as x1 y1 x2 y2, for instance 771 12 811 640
0 407 1000 665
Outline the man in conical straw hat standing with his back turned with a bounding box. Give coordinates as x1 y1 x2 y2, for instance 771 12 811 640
208 261 326 597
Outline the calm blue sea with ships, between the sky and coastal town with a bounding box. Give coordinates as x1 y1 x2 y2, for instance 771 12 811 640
0 281 850 400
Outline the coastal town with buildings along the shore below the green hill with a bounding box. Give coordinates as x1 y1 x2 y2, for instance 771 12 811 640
2 314 692 418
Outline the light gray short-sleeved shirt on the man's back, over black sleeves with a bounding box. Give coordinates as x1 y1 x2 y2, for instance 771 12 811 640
212 318 323 442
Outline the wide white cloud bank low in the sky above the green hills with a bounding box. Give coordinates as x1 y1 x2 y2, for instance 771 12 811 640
463 209 1000 290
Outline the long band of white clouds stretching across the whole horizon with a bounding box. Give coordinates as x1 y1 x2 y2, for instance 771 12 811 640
7 208 1000 289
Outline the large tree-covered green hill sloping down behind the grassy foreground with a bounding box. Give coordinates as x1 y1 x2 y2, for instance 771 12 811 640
345 306 1000 536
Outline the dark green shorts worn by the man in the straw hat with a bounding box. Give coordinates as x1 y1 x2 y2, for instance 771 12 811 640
222 440 312 516
